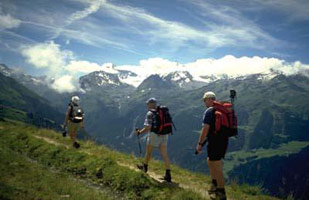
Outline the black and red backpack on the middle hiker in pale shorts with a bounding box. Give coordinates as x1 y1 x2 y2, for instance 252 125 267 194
151 106 176 135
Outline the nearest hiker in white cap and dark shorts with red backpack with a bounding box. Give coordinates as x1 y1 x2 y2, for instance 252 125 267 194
195 90 237 200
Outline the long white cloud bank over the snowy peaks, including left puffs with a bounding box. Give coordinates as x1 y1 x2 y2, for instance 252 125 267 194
22 41 309 92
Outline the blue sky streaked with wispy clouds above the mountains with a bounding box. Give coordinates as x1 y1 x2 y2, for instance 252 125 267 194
0 0 309 79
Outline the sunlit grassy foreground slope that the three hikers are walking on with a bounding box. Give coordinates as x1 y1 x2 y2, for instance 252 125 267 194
0 121 276 200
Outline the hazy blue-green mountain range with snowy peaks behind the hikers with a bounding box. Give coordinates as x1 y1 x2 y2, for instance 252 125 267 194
0 65 309 198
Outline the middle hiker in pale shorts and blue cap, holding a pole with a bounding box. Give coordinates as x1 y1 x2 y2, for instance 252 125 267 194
136 98 173 182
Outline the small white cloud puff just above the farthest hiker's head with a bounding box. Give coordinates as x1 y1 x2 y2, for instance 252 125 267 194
51 75 79 93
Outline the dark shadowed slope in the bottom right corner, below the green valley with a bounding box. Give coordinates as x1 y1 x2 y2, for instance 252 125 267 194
229 145 309 200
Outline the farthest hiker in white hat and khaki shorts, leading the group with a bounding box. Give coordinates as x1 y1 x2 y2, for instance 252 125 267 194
62 96 85 149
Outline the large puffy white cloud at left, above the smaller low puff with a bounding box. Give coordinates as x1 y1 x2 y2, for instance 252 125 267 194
21 41 73 73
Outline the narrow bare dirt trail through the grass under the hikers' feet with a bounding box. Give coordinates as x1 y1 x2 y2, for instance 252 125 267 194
34 135 211 199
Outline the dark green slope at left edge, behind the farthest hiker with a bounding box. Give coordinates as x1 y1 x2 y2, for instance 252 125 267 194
0 73 64 129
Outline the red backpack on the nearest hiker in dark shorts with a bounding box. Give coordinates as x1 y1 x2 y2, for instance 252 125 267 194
213 101 238 137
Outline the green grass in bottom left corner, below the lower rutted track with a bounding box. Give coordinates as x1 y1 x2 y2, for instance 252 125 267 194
0 137 111 200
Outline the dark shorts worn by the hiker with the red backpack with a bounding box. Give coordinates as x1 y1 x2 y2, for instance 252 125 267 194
207 134 229 161
